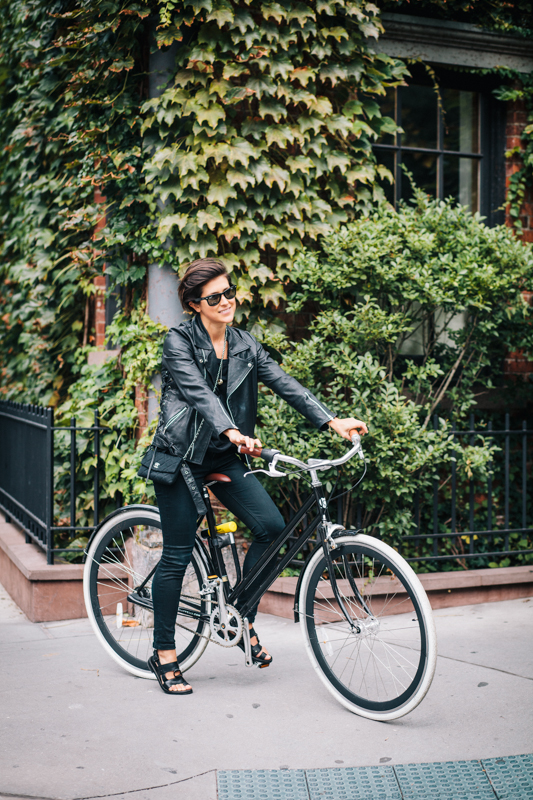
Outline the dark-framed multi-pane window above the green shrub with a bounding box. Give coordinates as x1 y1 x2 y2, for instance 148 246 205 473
374 67 505 225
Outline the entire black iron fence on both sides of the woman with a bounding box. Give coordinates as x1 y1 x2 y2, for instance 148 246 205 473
0 401 533 569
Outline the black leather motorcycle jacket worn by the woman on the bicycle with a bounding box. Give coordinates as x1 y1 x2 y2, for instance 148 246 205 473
154 315 334 464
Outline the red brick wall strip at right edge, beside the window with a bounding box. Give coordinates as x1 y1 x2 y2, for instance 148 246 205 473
504 95 533 380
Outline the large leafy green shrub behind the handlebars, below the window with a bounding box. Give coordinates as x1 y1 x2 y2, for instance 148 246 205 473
254 191 533 543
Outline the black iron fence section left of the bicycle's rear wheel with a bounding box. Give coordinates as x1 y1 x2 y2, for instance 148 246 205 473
0 400 109 564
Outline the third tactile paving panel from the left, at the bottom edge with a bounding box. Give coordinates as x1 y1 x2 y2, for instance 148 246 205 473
394 761 495 800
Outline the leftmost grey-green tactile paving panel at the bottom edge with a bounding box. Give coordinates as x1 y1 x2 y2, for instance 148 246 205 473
217 769 309 800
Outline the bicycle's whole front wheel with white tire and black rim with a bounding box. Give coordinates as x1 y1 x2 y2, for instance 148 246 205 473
299 532 437 720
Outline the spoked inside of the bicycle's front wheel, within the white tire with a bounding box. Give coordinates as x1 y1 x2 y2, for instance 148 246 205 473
302 542 425 718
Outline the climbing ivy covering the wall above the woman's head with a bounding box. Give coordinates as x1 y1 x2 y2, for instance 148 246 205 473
0 0 412 405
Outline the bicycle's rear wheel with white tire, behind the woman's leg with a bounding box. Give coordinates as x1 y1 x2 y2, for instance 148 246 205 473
83 506 211 679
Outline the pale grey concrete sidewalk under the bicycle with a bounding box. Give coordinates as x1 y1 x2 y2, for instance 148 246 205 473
0 580 533 800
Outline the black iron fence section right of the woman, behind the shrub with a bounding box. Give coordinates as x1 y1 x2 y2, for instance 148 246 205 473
289 414 533 571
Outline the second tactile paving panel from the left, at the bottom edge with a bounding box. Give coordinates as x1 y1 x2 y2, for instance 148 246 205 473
305 767 402 800
